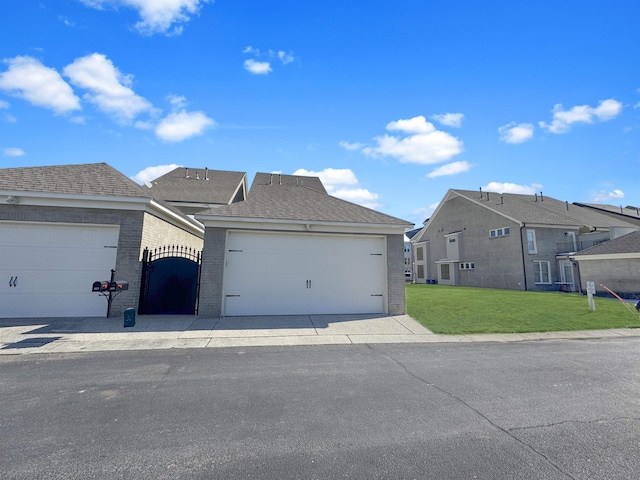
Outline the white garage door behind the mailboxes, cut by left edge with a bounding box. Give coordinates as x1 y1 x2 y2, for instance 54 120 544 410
0 222 119 318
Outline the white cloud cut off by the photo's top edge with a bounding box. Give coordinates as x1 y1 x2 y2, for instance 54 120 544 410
80 0 210 35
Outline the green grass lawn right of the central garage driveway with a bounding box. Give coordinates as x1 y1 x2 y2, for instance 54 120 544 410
406 284 640 334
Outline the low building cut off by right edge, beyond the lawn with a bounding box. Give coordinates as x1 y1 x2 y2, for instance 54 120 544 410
570 231 640 299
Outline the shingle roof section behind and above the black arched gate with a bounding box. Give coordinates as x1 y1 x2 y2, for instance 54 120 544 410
149 167 246 205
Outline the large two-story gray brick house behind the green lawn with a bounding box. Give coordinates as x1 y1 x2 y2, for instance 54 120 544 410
412 189 638 291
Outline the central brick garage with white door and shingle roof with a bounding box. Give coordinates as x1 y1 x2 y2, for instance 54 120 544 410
195 173 413 316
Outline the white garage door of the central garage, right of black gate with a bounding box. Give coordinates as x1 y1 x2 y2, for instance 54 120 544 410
224 232 386 316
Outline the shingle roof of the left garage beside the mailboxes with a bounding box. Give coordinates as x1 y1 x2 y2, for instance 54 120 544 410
0 163 149 198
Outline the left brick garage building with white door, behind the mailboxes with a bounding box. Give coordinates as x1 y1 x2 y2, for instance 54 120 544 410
0 163 204 317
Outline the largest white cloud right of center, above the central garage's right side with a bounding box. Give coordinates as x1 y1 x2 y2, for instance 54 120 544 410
362 116 462 165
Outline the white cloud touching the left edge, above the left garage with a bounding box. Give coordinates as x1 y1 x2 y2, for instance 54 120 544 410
0 56 82 114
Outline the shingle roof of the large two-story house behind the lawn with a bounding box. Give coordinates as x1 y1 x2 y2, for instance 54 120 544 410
452 190 633 228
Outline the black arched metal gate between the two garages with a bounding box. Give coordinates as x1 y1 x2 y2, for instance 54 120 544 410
138 246 202 315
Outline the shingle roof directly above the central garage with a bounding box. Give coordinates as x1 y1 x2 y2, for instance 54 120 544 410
196 173 413 227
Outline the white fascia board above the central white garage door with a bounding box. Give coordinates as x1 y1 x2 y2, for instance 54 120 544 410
196 215 407 235
